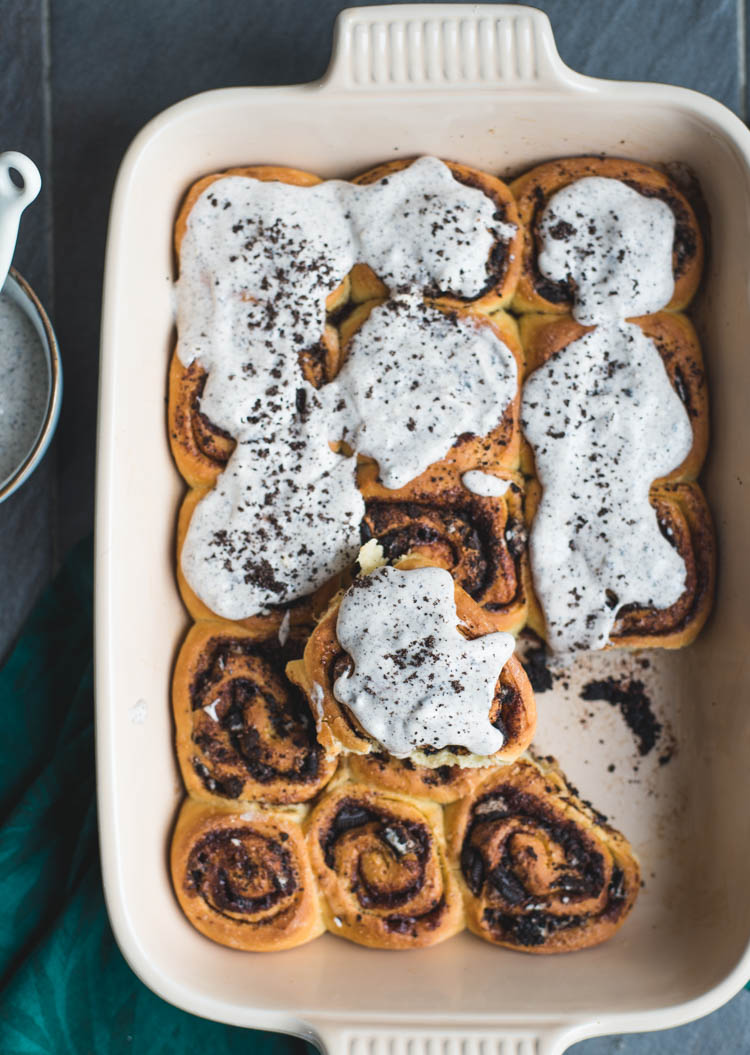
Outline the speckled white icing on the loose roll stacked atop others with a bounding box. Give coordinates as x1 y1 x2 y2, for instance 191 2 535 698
333 567 514 757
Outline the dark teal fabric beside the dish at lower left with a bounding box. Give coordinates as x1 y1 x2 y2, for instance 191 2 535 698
0 541 312 1055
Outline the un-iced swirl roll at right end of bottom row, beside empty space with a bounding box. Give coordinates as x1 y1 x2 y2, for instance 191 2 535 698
446 759 640 953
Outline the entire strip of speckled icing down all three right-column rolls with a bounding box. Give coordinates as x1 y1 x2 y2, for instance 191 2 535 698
521 176 692 652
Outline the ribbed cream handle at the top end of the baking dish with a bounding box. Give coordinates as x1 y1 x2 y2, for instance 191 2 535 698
323 4 589 92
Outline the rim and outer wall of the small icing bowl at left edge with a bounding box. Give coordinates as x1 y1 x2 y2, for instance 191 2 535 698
0 268 62 502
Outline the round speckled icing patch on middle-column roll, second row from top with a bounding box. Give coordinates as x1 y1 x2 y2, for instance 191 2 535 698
327 292 518 487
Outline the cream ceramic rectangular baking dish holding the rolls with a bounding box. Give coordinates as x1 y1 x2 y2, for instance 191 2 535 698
96 5 750 1053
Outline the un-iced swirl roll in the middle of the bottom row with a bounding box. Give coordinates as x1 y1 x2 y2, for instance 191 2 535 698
308 784 463 948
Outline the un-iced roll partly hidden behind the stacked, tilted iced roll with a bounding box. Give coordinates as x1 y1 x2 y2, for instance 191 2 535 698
358 462 531 633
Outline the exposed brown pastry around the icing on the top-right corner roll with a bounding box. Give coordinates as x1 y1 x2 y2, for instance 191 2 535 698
511 157 704 314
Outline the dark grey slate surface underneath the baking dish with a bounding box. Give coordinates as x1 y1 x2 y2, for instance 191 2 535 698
0 0 750 1055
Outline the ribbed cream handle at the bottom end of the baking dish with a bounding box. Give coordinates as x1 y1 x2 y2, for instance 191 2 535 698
314 1022 588 1055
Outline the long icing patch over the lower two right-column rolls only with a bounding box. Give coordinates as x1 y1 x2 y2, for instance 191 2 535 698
521 322 692 652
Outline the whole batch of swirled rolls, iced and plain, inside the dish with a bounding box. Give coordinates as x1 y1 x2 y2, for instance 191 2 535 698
169 157 714 953
